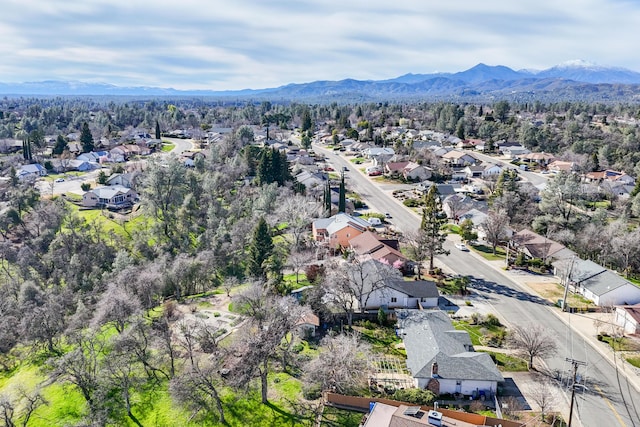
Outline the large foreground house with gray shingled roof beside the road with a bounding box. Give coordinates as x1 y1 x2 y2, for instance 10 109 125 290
396 310 504 396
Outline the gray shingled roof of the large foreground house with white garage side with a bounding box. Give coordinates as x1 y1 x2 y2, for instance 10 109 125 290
397 310 504 381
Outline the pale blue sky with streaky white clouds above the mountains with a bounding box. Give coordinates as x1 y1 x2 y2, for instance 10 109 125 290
0 0 640 90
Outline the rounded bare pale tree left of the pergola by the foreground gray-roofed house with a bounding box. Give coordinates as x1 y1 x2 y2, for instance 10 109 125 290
304 334 371 394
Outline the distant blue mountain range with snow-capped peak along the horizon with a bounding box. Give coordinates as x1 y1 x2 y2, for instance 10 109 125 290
0 61 640 102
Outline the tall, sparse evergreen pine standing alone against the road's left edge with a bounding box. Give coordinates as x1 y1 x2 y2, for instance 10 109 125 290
420 185 449 270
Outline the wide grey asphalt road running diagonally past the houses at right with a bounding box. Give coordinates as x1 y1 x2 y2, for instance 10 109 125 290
314 146 640 427
